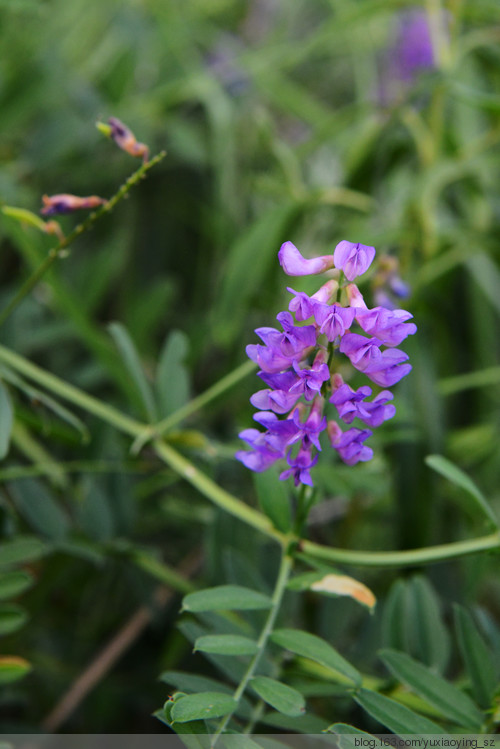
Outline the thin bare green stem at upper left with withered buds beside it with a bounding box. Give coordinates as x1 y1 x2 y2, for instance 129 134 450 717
0 151 166 326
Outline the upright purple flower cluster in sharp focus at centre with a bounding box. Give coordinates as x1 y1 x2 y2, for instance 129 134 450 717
236 240 417 486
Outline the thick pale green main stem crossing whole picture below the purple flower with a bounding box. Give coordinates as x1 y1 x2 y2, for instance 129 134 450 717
0 346 500 567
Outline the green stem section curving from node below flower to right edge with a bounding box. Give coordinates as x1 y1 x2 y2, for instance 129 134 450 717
300 532 500 567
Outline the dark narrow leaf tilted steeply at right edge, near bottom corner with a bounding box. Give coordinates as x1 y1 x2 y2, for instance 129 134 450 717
453 605 497 709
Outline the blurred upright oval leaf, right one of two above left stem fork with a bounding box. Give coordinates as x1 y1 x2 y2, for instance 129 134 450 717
156 330 189 417
